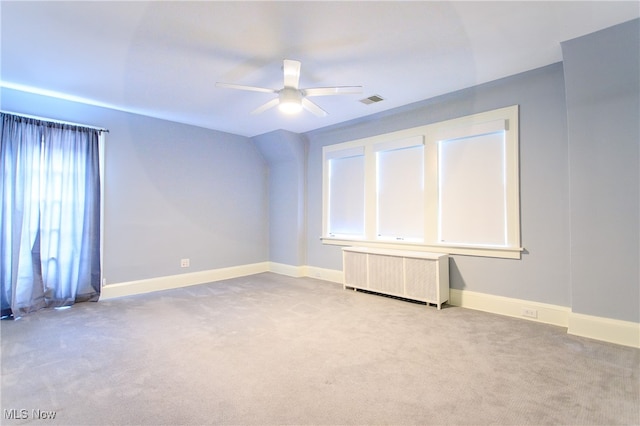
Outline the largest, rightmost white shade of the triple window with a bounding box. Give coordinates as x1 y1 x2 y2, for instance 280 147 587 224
438 131 508 247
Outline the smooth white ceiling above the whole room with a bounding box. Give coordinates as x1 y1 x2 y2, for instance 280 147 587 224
0 1 640 136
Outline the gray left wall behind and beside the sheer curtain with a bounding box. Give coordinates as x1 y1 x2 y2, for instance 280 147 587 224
1 89 268 283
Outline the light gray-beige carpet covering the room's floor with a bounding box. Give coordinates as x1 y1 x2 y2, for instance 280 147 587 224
0 273 640 425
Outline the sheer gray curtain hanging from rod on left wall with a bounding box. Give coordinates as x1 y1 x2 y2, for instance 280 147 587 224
0 113 100 317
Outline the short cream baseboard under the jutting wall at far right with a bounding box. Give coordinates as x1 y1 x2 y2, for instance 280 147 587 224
567 312 640 348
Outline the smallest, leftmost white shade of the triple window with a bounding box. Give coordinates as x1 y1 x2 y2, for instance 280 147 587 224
328 155 365 238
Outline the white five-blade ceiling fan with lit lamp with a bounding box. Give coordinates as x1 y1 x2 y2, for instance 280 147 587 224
216 59 362 117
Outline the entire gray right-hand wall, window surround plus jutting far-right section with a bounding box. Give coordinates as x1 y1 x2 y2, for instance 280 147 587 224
306 20 640 322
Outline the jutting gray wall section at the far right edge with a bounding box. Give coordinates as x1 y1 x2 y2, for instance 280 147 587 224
562 20 640 322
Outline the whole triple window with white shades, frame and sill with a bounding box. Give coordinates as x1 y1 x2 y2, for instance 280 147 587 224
323 106 522 258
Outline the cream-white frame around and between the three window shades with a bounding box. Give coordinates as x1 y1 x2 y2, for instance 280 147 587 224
320 105 523 259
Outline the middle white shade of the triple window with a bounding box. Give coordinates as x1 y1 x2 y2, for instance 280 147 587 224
376 144 424 241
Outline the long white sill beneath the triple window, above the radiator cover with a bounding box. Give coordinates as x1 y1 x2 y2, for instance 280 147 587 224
320 237 524 259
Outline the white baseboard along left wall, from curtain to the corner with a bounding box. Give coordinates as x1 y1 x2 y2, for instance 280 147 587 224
100 262 269 300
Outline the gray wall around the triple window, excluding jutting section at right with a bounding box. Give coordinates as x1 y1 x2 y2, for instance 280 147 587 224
306 64 570 306
